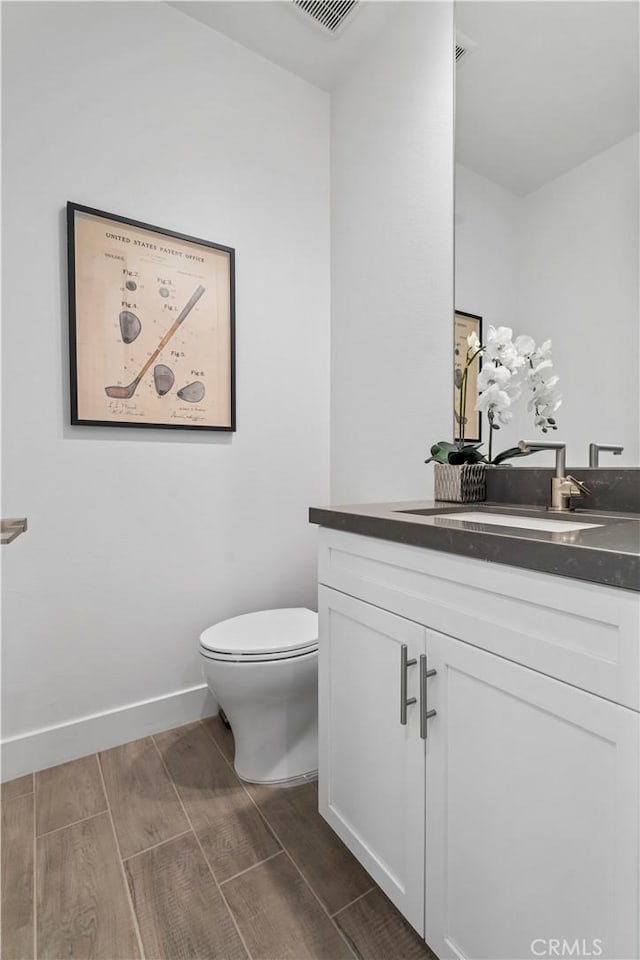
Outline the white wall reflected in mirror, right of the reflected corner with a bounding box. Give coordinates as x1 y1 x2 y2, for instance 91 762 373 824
518 134 640 467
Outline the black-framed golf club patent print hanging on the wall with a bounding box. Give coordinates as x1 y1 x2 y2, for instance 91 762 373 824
66 201 236 432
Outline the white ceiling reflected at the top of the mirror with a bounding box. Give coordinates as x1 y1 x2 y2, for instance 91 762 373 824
456 0 640 195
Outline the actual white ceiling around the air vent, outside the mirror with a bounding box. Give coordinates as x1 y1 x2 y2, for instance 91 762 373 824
171 0 398 90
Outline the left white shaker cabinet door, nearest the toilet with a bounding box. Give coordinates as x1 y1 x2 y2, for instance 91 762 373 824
318 587 426 934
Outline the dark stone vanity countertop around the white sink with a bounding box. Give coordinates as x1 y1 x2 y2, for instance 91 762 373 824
309 500 640 591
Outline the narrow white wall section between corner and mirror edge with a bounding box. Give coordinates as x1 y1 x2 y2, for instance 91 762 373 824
331 3 453 503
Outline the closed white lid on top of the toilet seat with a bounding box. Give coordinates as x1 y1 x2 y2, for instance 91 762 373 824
200 607 318 653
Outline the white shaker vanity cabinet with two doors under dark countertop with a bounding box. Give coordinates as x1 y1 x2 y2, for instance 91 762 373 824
319 529 640 960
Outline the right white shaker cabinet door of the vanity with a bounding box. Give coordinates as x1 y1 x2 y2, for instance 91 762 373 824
425 631 640 960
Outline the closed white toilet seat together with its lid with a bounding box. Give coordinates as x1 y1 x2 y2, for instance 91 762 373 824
200 607 318 663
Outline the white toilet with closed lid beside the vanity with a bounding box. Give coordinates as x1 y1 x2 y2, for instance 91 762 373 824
200 607 318 783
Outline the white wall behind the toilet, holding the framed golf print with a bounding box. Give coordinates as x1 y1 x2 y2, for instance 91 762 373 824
2 3 329 777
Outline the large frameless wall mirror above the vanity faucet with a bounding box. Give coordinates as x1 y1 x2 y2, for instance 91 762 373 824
455 0 640 467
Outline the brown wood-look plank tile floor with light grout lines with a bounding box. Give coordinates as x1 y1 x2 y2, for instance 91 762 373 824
0 717 437 960
